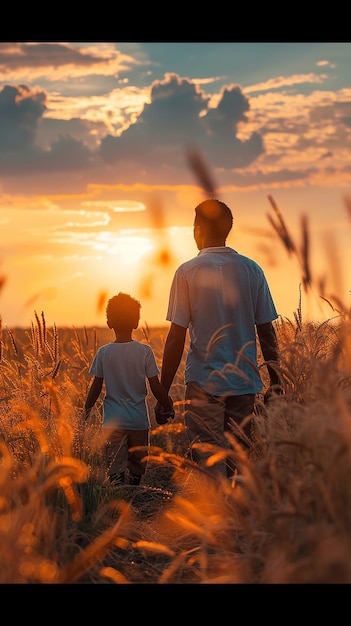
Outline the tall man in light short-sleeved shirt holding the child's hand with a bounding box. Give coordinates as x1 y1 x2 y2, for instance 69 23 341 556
156 199 280 477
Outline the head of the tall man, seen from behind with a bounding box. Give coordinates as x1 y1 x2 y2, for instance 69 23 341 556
194 198 233 250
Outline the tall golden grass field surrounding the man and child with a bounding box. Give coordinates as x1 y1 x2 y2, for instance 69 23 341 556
0 315 351 584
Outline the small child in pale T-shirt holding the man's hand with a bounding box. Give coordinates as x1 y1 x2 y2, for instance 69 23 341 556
85 293 174 485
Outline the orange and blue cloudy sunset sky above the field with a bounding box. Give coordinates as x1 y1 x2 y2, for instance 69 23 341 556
0 41 351 328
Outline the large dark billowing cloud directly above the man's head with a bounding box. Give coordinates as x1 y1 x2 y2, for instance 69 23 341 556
101 74 263 171
